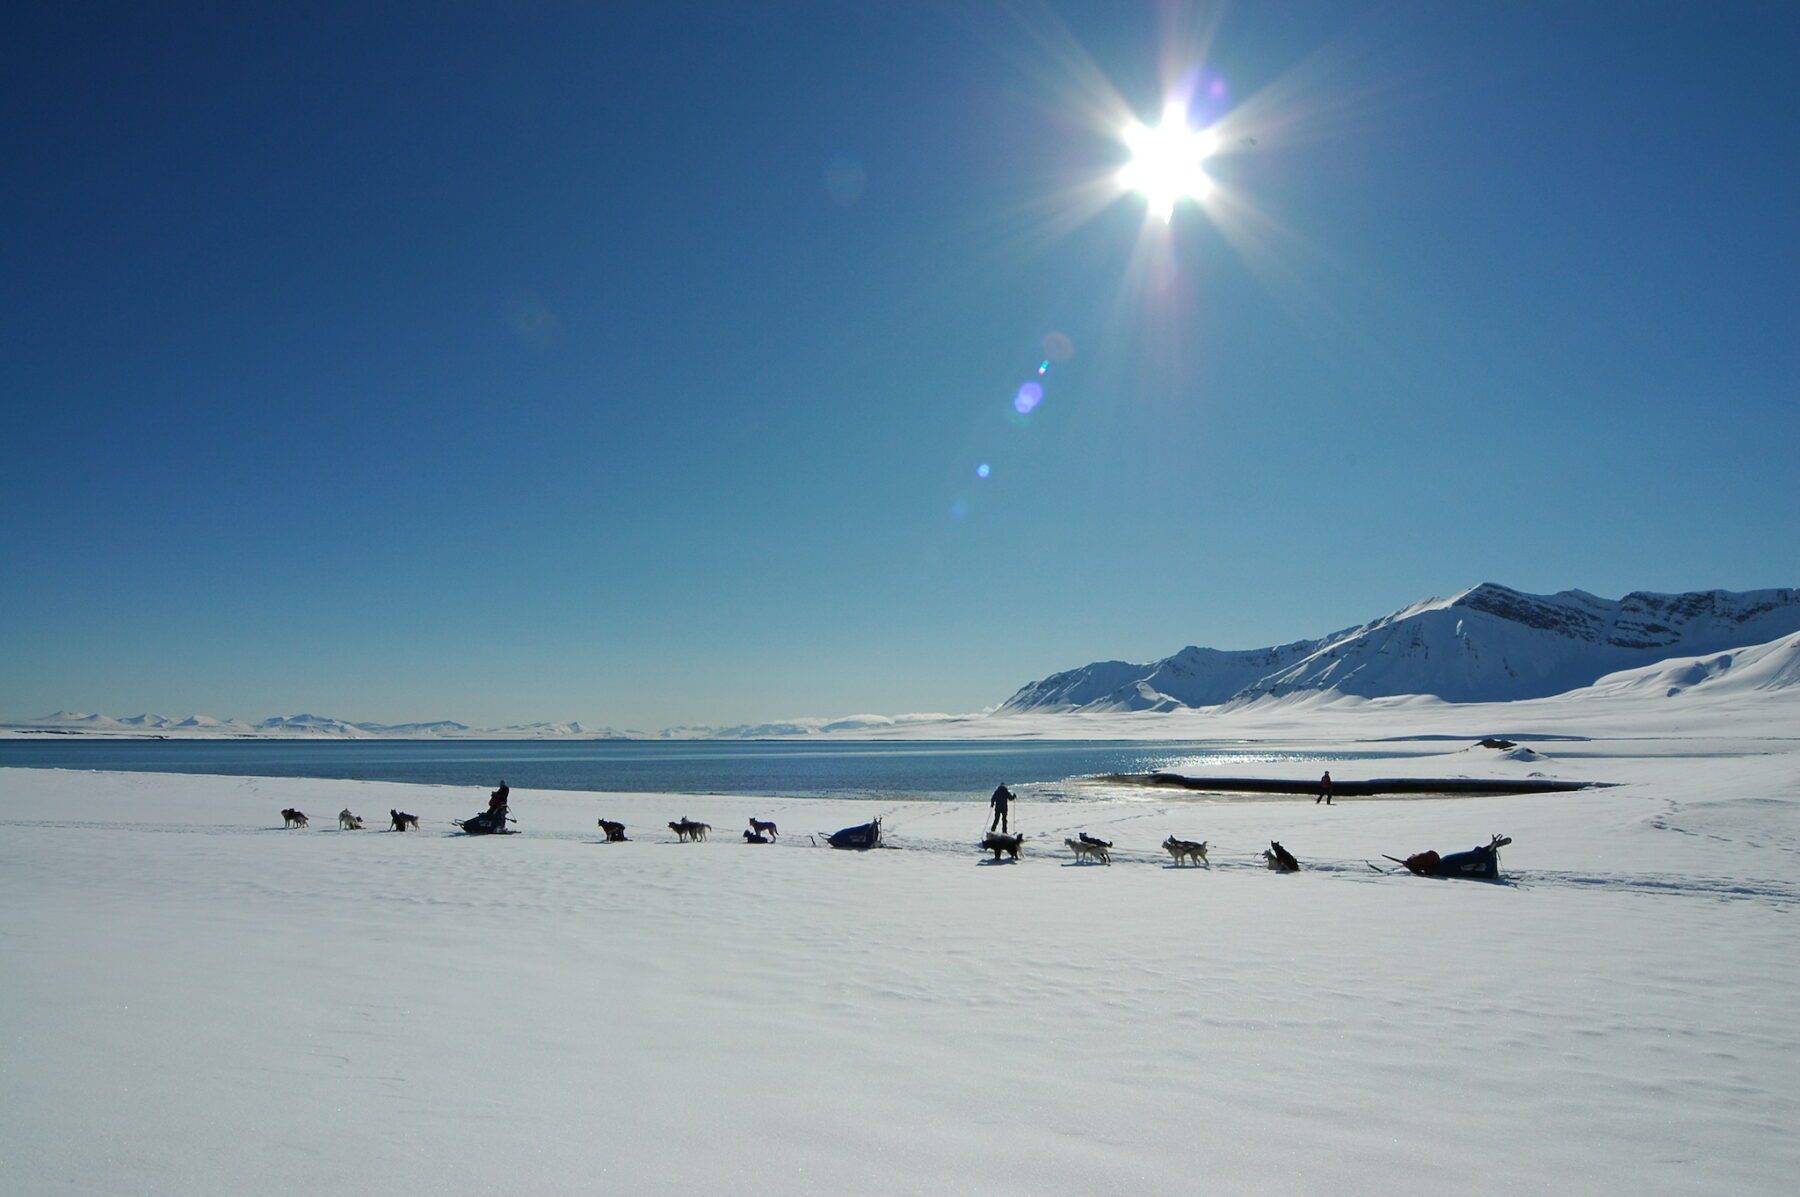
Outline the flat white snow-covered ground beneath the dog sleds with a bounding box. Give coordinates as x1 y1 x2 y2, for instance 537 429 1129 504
0 711 1800 1197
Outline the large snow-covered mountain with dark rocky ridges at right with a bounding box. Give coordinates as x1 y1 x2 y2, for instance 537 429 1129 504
1001 583 1800 711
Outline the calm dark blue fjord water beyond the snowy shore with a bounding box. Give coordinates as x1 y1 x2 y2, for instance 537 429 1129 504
0 738 1404 799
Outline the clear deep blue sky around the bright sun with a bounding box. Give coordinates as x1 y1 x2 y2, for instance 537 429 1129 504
0 0 1800 729
